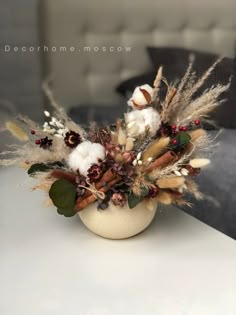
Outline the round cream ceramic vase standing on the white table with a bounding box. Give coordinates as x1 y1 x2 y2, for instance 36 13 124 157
79 202 157 239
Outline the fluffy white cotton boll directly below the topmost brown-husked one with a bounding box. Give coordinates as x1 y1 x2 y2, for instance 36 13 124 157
125 107 161 137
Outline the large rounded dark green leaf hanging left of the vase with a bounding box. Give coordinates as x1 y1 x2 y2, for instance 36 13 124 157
49 179 76 216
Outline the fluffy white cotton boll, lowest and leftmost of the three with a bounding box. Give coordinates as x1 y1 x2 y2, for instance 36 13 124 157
68 141 105 176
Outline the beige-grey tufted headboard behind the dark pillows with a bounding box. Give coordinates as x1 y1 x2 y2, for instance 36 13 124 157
41 0 236 108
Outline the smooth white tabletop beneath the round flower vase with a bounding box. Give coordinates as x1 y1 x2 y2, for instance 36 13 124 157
0 169 236 315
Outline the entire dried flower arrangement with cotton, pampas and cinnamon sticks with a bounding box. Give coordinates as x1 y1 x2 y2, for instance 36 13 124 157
0 61 230 217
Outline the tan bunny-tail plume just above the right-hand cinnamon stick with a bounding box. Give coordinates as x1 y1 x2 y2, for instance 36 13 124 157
142 137 170 162
